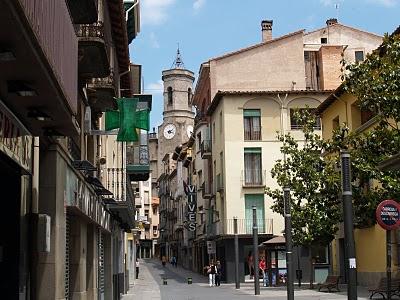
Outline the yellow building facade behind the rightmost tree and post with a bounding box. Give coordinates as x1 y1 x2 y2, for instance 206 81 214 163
318 87 398 286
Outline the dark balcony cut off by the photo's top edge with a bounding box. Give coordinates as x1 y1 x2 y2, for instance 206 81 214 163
67 0 98 24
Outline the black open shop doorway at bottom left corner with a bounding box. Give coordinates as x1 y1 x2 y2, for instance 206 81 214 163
0 154 21 299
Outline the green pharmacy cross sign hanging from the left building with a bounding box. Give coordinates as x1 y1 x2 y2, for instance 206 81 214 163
105 98 150 142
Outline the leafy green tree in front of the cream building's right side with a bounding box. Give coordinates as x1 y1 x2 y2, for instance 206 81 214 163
265 110 341 246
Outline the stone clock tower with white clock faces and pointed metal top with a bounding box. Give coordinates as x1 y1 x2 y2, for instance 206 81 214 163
158 48 194 174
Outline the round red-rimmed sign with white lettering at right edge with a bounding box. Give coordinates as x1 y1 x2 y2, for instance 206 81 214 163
375 200 400 230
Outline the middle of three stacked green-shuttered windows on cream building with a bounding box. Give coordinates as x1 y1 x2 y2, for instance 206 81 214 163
244 148 263 186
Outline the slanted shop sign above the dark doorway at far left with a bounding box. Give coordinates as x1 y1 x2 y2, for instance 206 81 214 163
0 101 33 173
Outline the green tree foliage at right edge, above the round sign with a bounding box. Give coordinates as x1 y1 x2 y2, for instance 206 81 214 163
343 35 400 227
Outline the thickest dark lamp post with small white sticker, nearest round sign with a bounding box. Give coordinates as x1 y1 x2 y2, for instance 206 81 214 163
340 150 357 300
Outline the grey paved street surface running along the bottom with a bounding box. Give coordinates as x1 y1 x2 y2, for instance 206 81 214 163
122 260 369 300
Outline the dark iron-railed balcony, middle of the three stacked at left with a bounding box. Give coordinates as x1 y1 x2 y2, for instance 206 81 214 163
77 21 110 79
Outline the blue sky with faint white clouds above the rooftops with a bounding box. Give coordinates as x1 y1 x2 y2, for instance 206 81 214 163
130 0 400 130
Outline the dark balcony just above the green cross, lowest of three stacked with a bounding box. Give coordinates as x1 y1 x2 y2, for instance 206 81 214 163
87 72 117 112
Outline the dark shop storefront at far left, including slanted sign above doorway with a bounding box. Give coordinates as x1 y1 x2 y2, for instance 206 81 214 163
0 101 33 299
